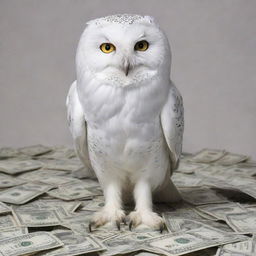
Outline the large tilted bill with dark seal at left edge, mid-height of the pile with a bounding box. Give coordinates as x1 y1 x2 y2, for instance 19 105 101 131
0 183 52 204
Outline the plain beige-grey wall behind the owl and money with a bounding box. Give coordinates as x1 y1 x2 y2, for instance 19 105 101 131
0 0 256 158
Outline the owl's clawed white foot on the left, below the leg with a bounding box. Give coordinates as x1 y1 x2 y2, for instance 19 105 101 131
88 208 126 232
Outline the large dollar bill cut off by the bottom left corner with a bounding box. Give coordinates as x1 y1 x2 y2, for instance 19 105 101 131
0 232 63 256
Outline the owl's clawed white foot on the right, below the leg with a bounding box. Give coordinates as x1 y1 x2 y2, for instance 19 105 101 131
128 211 166 233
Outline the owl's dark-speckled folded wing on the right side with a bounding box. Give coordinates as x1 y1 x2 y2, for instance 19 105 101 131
160 82 184 174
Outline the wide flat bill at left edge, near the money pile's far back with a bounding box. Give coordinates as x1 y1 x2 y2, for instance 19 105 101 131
0 160 43 175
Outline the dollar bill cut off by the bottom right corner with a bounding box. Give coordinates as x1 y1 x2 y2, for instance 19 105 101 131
216 236 256 256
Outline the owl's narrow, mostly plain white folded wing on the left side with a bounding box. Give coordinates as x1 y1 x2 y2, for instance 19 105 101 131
66 81 95 178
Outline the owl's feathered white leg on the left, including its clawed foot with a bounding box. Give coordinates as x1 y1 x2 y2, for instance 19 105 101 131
89 182 125 231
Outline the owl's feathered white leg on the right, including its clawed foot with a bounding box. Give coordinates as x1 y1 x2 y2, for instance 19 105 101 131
128 180 165 232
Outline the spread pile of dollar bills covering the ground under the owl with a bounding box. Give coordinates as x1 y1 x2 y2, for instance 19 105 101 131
0 145 256 256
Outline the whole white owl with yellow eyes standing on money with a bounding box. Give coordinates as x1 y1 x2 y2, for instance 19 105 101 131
66 14 184 230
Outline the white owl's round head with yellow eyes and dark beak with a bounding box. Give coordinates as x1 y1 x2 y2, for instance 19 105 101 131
76 14 171 87
